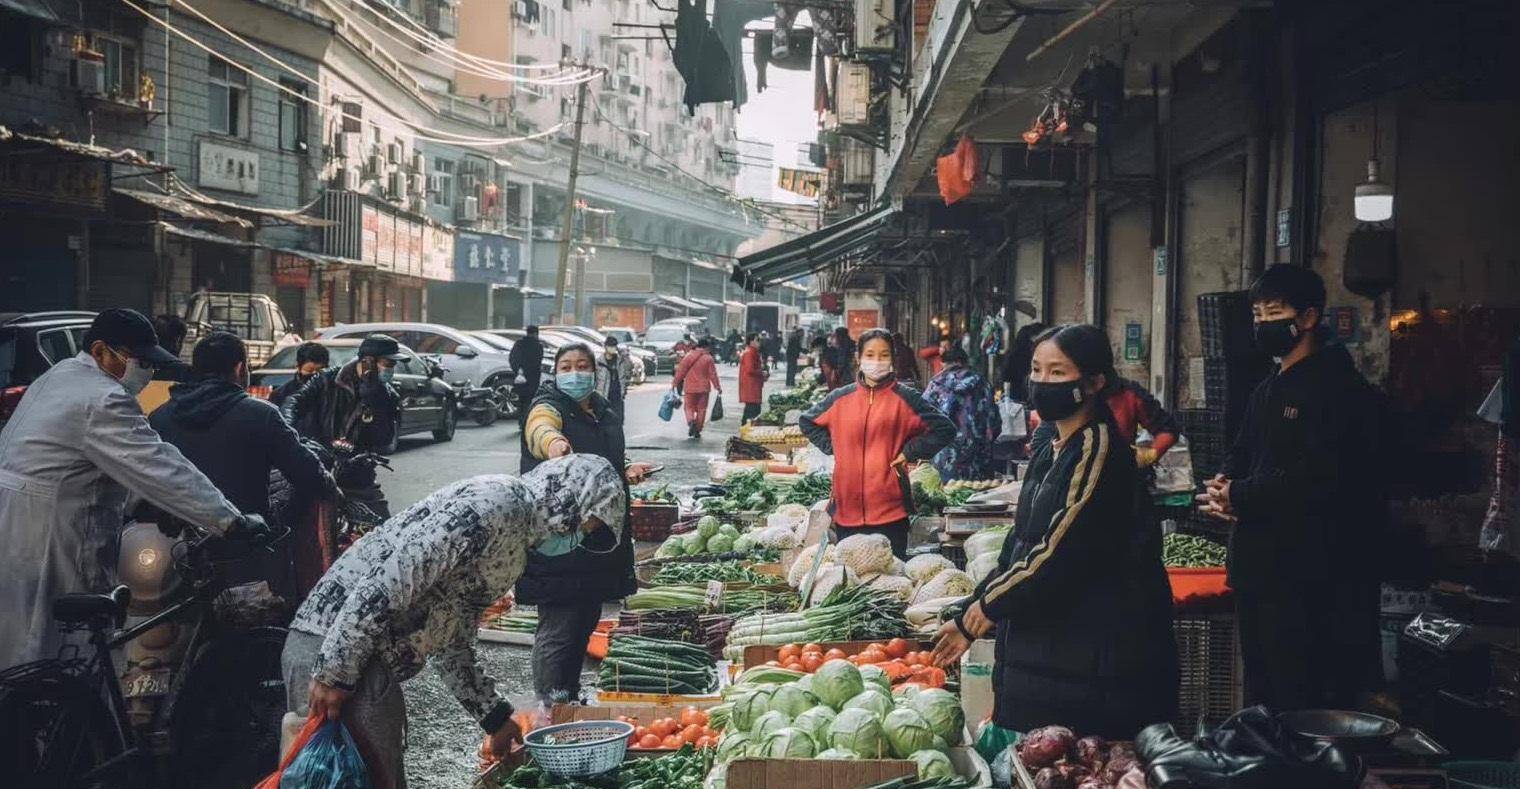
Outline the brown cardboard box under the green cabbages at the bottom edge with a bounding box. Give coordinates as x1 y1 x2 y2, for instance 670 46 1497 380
725 746 993 789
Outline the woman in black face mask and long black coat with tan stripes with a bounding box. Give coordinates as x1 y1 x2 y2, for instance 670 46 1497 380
935 325 1176 739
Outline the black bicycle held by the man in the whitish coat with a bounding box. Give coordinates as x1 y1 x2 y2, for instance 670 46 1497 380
0 524 286 789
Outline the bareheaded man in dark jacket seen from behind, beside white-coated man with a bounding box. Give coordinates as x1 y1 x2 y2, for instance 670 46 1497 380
147 331 328 599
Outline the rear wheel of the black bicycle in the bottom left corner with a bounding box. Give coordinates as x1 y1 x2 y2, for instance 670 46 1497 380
0 660 141 789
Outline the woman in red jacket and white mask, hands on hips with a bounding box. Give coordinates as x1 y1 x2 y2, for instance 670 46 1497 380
801 328 955 558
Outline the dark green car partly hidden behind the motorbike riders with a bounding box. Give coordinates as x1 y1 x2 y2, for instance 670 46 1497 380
248 337 459 441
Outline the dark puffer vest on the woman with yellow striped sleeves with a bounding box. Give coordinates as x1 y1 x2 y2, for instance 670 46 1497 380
517 382 638 605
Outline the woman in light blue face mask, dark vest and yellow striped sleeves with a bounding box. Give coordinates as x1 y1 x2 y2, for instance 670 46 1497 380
517 344 649 701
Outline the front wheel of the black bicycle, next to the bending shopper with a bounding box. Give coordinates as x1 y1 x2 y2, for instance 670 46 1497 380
169 628 286 789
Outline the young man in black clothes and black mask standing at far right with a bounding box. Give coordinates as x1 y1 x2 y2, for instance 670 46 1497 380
1199 265 1385 710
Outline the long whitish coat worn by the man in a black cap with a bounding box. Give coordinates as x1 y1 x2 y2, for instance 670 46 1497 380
0 353 239 667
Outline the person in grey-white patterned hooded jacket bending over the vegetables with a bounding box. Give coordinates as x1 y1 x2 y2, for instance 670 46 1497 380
281 455 626 787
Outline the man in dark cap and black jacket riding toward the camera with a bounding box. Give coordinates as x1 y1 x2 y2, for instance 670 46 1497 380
280 334 401 518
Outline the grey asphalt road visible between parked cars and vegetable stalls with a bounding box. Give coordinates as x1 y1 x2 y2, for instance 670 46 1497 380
380 365 786 789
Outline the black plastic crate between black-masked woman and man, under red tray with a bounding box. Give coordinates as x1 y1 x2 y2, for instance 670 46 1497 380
1172 613 1245 737
